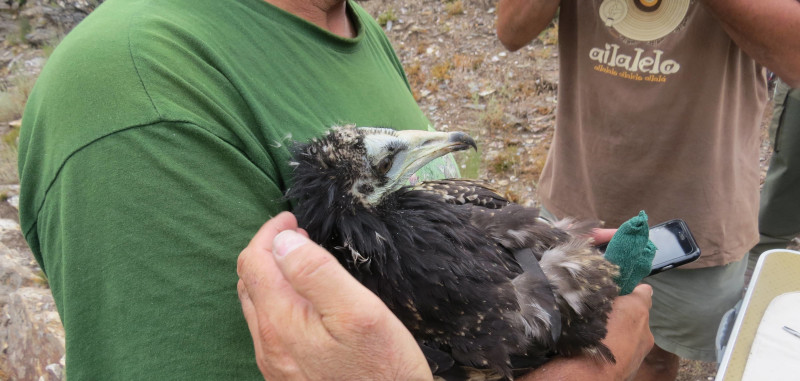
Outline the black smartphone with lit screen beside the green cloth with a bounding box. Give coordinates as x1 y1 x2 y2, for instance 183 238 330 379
650 219 700 275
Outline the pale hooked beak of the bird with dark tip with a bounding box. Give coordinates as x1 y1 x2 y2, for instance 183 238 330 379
397 130 478 175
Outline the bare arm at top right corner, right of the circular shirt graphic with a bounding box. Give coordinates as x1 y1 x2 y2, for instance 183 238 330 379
703 0 800 87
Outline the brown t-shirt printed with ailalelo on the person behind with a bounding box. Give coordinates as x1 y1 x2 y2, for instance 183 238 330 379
539 0 767 268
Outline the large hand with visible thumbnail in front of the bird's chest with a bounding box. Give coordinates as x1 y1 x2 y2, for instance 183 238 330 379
237 213 432 380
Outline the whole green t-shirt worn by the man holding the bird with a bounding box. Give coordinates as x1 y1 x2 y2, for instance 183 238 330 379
20 0 456 380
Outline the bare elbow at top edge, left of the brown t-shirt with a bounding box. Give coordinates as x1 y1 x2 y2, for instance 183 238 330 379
497 0 561 51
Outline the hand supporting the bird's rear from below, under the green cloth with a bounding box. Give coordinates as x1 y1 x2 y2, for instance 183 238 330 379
520 284 653 381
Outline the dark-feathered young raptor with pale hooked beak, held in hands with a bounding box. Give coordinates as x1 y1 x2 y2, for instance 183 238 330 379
285 125 619 380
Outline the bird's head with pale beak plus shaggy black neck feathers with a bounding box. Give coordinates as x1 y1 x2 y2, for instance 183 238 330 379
286 126 475 271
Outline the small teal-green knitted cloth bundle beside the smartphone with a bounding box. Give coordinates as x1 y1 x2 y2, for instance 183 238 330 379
605 210 656 295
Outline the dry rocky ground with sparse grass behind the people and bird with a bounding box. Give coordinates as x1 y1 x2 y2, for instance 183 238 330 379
0 0 788 381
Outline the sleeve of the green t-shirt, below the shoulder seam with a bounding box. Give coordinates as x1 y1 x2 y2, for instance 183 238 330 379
37 123 282 380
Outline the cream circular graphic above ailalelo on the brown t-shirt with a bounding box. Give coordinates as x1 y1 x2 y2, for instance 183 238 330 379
599 0 691 41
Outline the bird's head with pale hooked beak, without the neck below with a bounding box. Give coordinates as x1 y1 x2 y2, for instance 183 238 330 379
289 126 477 212
